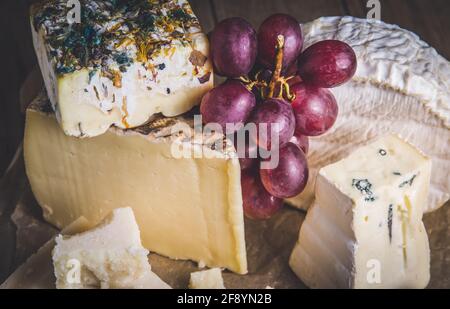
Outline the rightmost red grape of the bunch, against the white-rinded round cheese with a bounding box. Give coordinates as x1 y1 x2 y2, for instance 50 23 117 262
298 40 357 88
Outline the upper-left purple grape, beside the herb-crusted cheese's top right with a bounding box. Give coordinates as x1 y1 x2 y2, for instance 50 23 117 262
211 17 258 77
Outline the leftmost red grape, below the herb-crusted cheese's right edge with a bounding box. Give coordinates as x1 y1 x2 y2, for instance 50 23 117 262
200 80 256 134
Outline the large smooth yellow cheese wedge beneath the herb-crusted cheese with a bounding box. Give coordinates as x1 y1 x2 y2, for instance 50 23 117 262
24 91 247 273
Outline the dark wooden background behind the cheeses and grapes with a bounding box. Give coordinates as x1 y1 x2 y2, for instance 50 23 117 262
0 0 450 177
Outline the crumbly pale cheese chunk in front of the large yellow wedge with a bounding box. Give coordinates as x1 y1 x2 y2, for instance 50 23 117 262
53 207 170 289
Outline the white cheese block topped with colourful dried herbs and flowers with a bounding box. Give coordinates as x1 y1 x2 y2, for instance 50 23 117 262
31 0 213 137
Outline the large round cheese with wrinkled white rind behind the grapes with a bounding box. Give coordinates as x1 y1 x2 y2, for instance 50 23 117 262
290 17 450 212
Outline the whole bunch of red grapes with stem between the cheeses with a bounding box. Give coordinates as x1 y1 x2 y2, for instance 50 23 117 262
200 14 357 220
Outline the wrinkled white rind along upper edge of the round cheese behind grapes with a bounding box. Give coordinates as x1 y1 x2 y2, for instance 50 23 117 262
303 16 450 124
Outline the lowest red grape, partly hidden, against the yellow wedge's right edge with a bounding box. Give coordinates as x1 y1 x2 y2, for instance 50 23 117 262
241 170 283 220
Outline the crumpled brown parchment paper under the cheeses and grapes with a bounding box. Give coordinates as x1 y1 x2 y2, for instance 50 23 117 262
0 150 450 289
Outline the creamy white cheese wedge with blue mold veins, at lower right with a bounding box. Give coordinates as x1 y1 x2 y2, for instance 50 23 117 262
289 135 431 288
